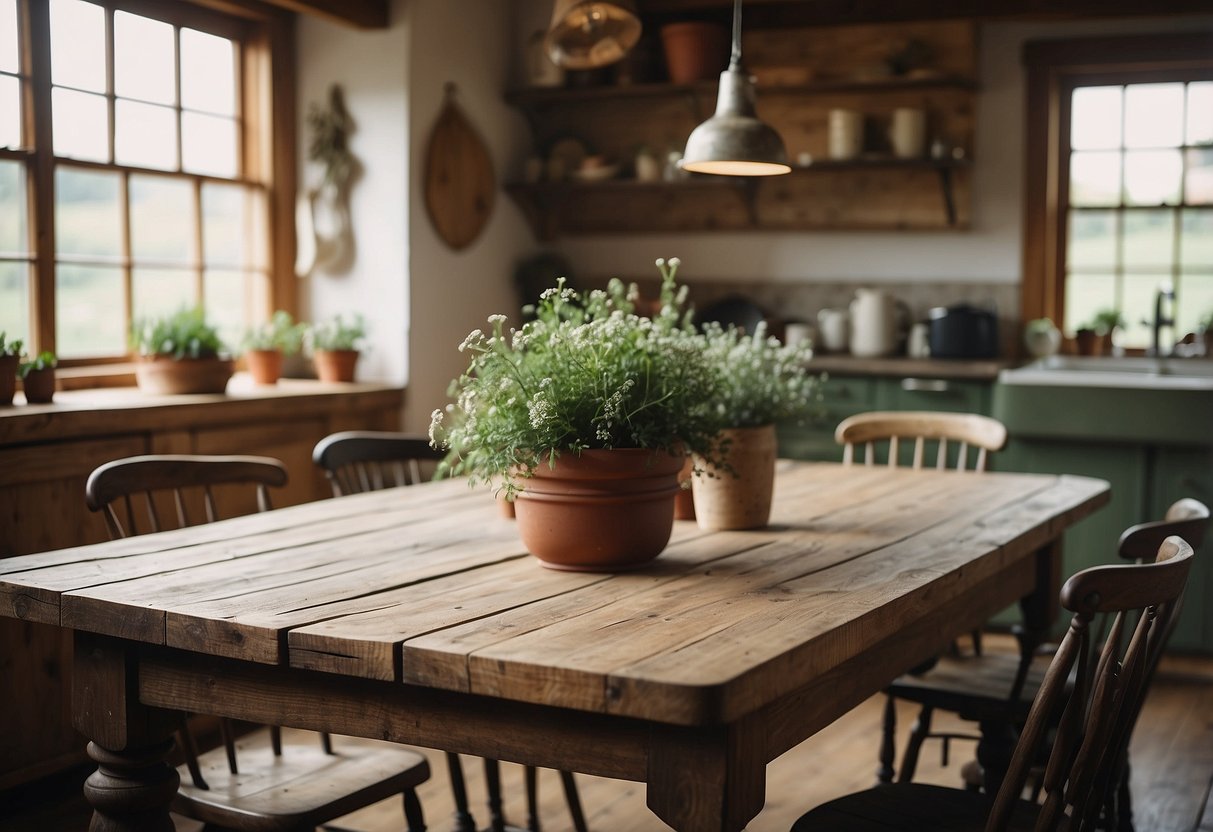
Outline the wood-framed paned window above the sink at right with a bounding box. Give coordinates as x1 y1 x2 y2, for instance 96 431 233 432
1024 35 1213 349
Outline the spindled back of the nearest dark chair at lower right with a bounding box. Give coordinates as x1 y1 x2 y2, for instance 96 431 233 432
986 537 1192 832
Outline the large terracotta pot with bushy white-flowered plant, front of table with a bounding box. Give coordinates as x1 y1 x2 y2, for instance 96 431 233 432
429 261 719 571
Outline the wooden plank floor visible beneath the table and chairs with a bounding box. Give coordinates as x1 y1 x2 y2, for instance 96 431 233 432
0 659 1213 832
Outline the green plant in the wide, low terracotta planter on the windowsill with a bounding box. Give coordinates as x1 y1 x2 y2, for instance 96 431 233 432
131 308 233 394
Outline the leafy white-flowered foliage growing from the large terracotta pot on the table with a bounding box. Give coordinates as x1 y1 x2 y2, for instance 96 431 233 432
429 258 721 496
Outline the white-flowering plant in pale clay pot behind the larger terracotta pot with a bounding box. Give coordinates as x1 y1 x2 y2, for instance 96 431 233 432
691 321 821 530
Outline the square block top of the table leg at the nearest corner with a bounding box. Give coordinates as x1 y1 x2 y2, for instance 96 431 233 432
648 718 767 832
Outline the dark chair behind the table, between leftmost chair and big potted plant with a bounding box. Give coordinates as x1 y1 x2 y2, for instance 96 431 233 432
312 431 587 832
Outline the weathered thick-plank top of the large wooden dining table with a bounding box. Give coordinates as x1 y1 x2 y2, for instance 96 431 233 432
0 462 1107 828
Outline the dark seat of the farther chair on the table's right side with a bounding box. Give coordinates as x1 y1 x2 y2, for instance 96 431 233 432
888 653 1049 722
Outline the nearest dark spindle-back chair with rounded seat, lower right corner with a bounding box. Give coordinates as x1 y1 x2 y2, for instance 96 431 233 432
792 537 1192 832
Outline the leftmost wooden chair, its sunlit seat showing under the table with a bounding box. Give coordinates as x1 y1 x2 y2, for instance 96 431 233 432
85 455 429 832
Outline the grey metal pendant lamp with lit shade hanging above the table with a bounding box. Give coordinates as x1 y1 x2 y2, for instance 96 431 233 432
682 0 792 176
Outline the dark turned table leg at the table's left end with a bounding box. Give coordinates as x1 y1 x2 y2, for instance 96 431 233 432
72 633 181 832
